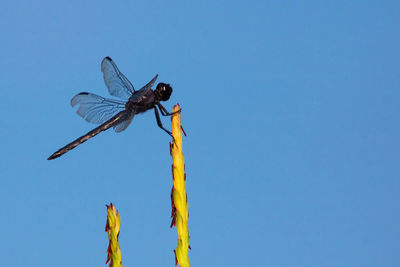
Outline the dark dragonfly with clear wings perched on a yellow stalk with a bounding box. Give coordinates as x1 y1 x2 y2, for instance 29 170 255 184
48 57 180 160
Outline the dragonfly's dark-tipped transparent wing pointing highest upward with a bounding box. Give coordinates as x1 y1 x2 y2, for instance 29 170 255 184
101 57 135 100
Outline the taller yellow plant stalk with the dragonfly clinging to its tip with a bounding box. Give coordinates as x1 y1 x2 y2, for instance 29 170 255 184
170 105 190 267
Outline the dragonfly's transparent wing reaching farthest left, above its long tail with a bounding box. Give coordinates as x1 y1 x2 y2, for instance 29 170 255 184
71 92 125 124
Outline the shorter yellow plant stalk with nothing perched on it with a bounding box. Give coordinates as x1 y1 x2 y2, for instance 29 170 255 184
106 203 122 267
